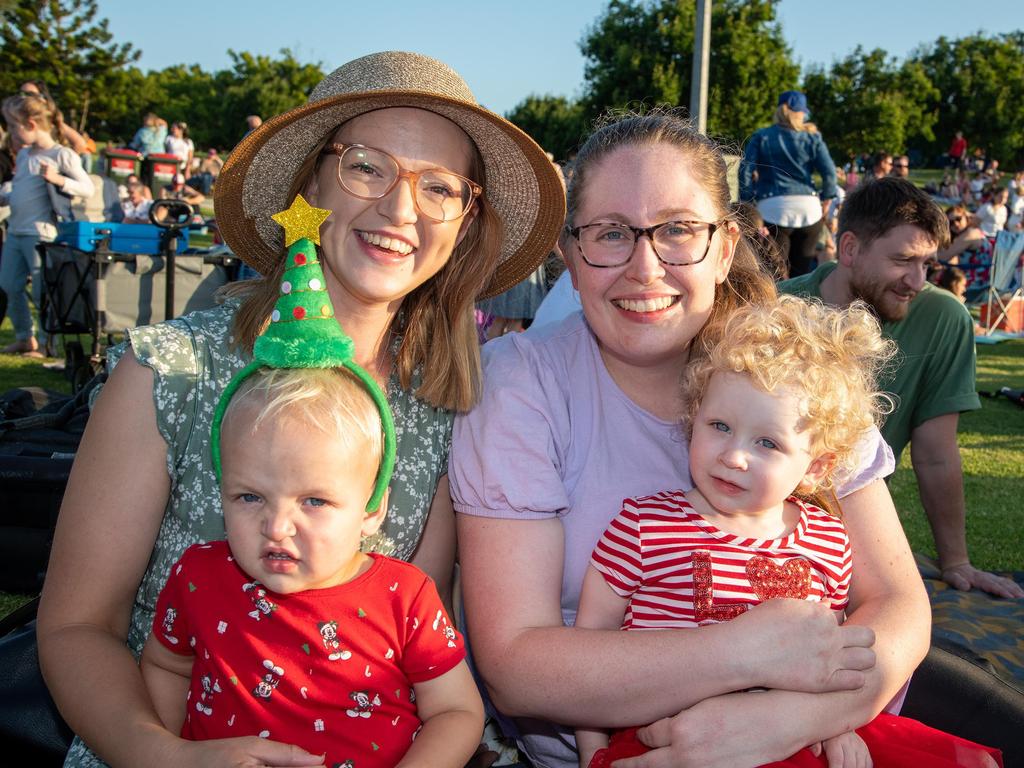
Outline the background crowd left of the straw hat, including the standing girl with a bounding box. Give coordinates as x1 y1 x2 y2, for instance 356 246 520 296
0 80 256 357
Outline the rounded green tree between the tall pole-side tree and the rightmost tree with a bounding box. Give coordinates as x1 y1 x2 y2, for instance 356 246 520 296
803 46 937 165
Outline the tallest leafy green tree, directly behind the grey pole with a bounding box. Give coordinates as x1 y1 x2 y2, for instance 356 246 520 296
580 0 800 143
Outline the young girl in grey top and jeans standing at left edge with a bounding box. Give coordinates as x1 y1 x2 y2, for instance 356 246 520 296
0 95 93 357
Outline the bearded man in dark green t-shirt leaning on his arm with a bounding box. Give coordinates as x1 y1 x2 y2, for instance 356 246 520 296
778 177 1024 597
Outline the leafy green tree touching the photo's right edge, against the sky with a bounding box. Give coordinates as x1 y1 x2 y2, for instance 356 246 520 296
910 31 1024 163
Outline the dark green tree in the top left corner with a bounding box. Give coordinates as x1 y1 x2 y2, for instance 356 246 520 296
0 0 140 132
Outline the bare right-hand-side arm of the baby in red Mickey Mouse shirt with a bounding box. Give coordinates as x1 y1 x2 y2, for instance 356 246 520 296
398 662 483 768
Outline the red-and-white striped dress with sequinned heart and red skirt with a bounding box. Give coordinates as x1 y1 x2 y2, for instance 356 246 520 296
589 490 1002 768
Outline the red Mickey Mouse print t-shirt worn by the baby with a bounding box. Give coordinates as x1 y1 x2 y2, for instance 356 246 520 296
154 543 464 768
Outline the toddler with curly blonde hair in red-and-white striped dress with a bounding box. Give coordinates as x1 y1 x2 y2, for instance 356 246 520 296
577 296 1001 768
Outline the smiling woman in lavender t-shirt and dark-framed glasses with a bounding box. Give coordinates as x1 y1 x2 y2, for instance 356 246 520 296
449 112 929 768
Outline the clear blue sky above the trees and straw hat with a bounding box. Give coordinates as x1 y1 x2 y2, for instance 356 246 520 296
98 0 1024 113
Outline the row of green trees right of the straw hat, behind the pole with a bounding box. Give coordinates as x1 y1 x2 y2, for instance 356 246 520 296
508 0 1024 164
